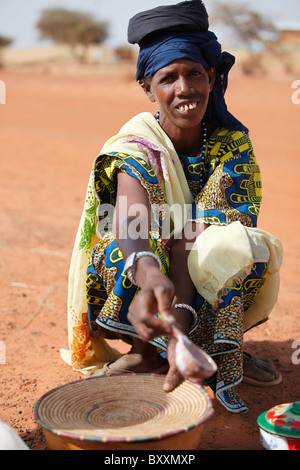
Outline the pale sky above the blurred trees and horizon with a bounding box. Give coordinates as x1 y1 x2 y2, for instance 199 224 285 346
0 0 300 49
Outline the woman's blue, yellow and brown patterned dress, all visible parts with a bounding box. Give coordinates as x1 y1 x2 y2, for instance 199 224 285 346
86 124 268 412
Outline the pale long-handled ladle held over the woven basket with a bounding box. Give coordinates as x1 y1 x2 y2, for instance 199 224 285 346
162 315 217 382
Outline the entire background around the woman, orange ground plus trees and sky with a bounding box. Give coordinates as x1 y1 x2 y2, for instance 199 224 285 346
0 0 300 450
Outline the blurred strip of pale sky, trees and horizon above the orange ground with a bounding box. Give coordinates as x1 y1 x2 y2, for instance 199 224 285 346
0 0 300 74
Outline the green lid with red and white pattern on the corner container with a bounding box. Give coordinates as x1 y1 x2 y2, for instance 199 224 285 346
257 401 300 439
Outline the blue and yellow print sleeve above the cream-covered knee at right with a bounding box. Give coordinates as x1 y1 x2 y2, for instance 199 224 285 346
193 129 262 227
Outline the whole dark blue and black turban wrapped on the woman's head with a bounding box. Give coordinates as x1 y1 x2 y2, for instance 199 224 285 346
128 0 248 133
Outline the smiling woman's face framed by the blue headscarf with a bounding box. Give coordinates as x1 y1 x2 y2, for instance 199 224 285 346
144 59 215 129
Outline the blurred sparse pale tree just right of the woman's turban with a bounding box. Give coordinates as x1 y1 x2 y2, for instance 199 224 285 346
211 1 280 73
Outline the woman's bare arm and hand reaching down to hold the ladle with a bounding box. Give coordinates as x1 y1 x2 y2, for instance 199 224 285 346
113 172 174 341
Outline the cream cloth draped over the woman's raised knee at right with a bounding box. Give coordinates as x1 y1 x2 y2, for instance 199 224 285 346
188 221 282 329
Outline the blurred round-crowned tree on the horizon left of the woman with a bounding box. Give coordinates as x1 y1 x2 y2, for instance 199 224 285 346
36 8 108 58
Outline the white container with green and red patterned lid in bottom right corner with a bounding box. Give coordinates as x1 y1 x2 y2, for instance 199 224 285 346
257 401 300 450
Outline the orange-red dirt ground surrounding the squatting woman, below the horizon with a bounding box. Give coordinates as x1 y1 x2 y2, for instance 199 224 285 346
0 60 300 450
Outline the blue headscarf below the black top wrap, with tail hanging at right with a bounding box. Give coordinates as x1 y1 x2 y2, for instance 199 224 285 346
136 30 248 134
